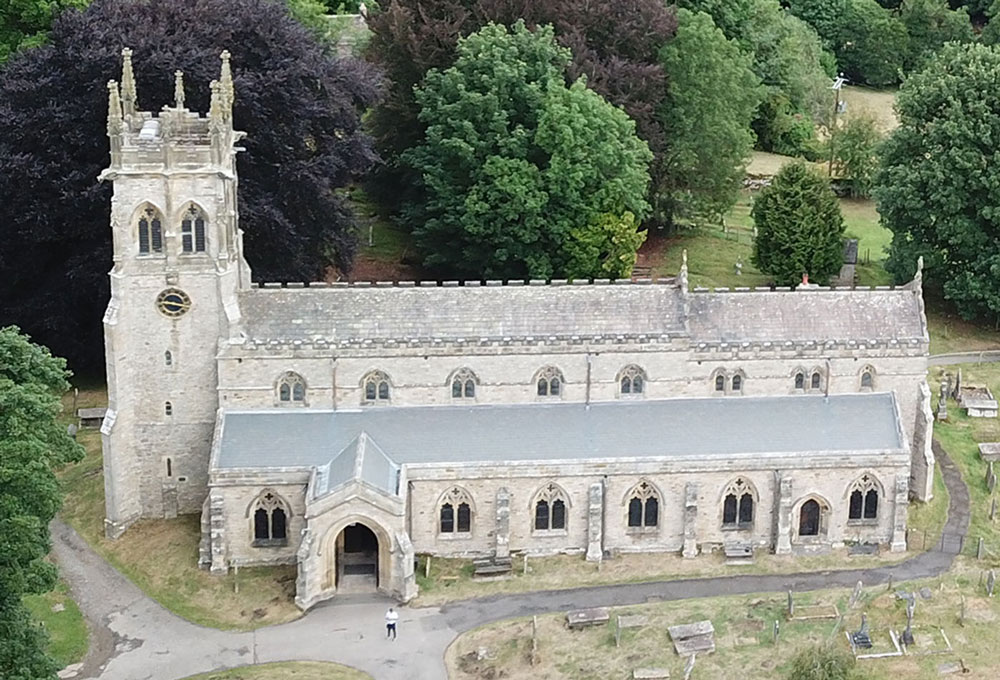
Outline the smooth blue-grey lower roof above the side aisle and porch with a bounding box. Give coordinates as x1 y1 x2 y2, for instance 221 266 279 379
215 393 902 472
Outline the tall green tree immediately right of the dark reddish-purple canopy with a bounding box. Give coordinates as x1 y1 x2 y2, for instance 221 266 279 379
654 8 763 219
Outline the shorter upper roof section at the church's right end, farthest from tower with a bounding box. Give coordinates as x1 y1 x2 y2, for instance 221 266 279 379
688 288 924 343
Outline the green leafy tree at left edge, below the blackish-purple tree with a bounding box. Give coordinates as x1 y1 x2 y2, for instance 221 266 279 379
0 327 83 680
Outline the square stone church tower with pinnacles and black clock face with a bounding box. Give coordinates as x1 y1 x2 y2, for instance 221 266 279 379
100 49 250 538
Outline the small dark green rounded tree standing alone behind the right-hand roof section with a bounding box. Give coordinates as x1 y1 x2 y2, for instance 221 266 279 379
750 161 844 286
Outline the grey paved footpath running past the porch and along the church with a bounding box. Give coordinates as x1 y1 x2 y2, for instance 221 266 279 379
53 443 969 680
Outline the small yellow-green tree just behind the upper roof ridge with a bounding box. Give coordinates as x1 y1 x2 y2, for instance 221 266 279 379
565 211 646 279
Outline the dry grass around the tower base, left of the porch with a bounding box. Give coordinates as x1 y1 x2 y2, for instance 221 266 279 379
59 388 301 630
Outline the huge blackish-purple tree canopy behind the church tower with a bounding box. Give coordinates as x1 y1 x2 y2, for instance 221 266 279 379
0 0 379 369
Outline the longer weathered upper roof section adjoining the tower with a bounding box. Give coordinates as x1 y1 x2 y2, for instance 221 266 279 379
240 284 684 341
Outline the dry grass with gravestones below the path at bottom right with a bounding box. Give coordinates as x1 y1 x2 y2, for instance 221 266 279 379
446 561 1000 680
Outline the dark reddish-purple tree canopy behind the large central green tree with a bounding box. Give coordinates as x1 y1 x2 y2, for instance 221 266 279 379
367 0 676 220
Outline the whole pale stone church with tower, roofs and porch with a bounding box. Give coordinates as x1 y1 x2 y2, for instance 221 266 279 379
101 50 934 608
